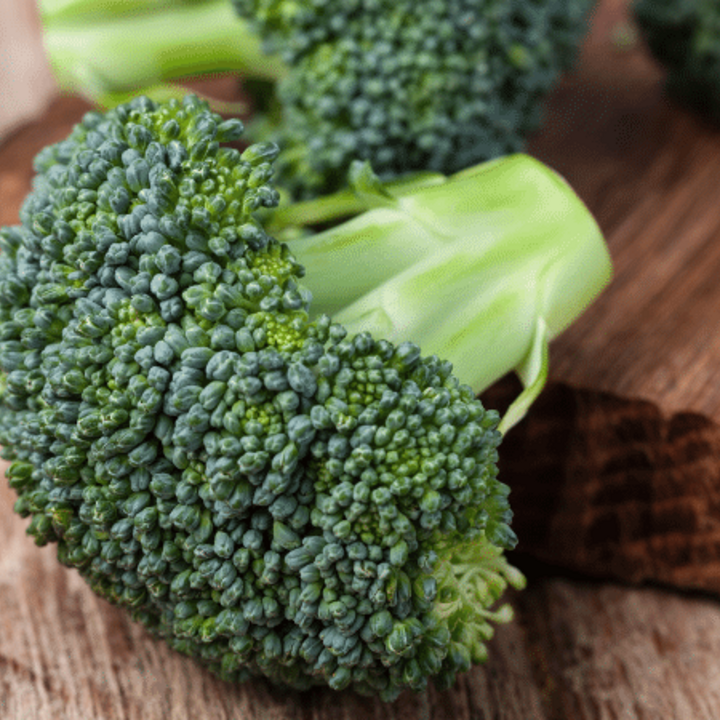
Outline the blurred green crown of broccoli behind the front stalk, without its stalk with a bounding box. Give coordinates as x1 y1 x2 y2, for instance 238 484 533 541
234 0 590 195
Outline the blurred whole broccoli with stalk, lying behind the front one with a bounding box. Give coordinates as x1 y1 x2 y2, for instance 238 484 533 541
36 0 592 197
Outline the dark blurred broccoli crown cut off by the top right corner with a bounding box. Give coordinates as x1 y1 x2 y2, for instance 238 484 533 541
633 0 720 123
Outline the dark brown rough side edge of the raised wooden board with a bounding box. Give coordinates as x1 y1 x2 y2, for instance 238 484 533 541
486 382 720 593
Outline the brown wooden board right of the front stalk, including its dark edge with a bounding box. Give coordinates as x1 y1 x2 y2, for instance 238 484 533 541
498 0 720 593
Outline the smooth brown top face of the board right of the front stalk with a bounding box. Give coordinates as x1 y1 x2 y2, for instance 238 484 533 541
532 0 720 421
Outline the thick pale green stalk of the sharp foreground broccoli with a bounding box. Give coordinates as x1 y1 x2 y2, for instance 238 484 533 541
281 155 612 429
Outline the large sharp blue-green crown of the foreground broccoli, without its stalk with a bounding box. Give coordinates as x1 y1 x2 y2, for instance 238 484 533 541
0 96 517 699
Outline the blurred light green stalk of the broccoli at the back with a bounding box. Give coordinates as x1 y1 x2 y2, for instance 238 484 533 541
40 0 285 107
